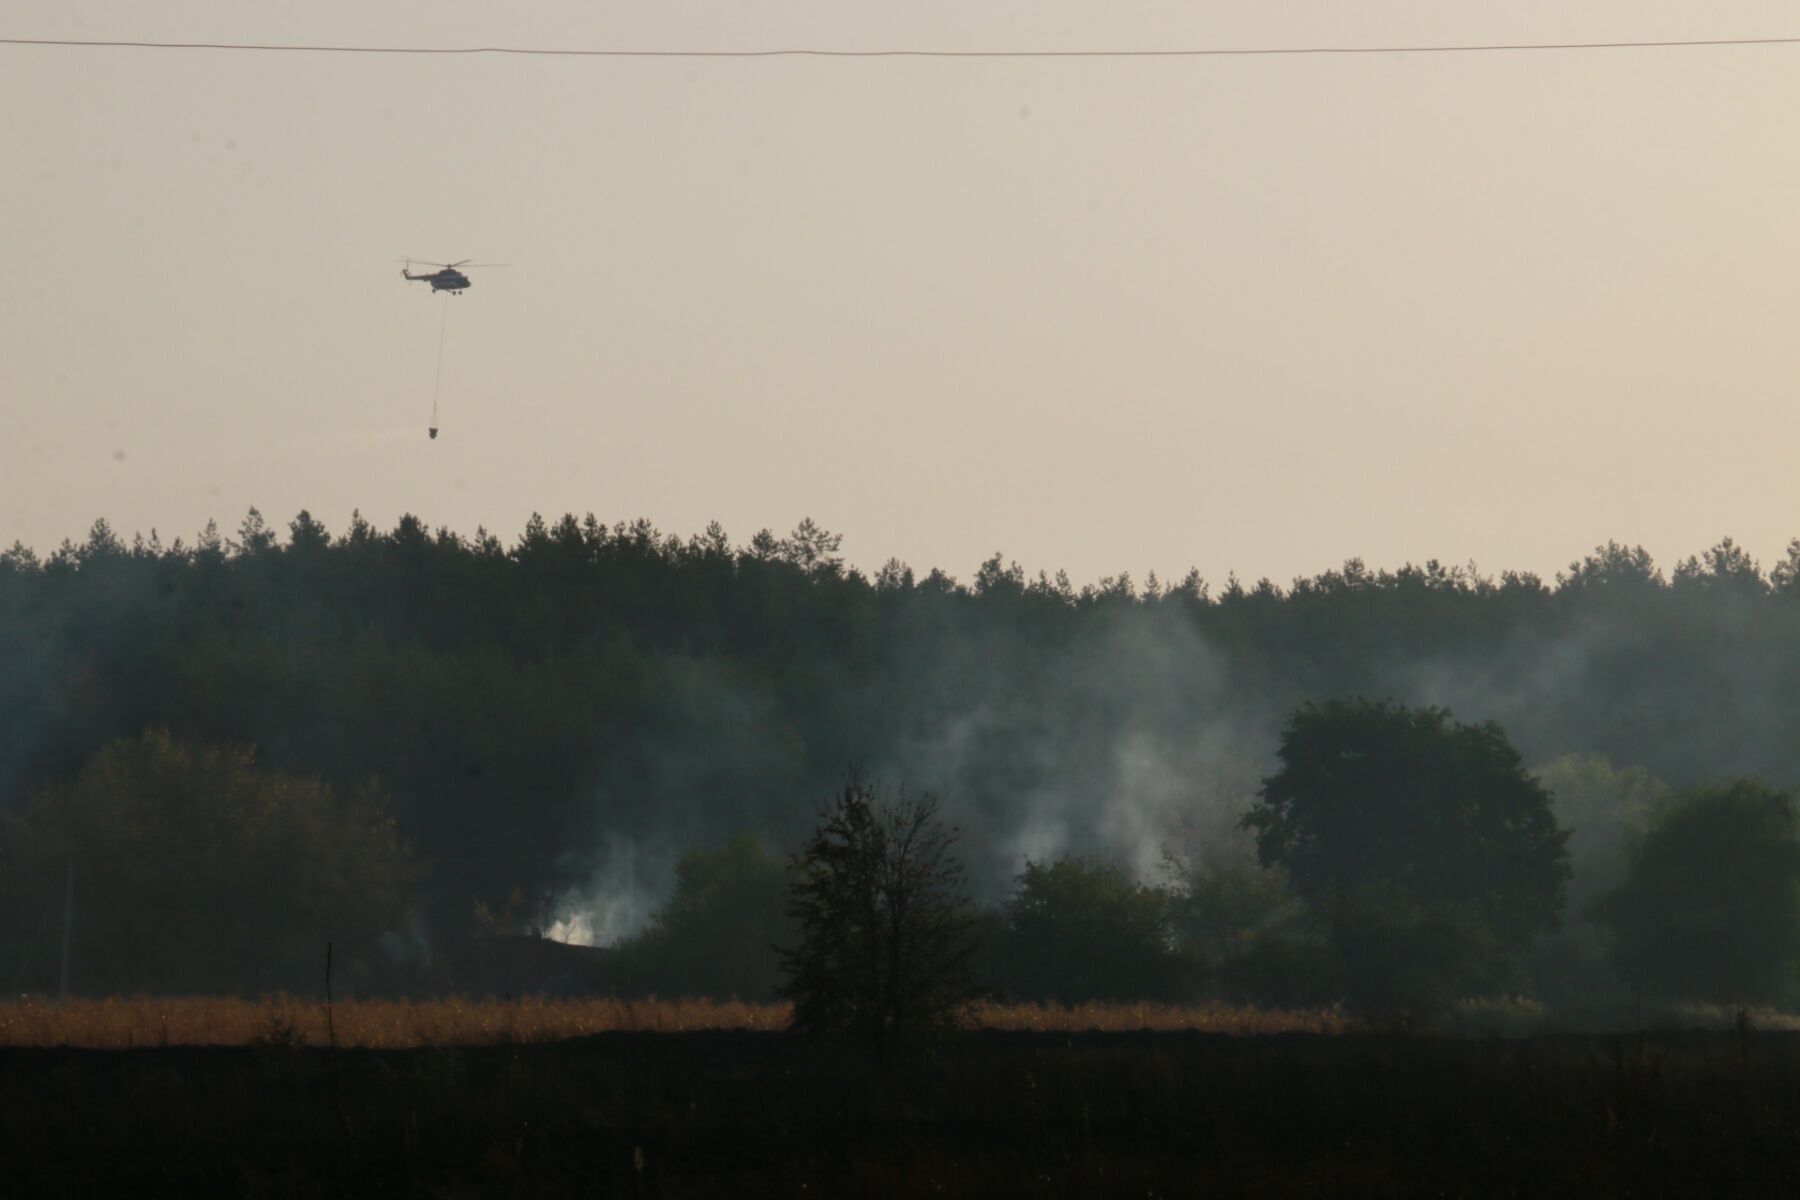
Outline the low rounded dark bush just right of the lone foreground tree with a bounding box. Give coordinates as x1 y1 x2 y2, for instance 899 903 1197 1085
1001 858 1181 1004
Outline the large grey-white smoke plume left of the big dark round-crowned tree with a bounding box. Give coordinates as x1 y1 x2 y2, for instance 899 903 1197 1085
878 606 1280 900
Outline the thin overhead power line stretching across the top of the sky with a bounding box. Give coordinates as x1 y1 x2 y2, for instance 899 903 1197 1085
0 36 1800 58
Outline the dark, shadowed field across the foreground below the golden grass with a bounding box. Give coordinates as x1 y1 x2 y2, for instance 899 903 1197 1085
0 1033 1800 1196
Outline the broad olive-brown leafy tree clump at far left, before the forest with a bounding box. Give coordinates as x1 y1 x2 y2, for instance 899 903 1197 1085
0 730 416 993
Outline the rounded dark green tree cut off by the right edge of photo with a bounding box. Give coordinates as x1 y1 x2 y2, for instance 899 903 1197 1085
1595 779 1800 1004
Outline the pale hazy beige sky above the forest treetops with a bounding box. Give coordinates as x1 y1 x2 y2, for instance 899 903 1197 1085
0 0 1800 581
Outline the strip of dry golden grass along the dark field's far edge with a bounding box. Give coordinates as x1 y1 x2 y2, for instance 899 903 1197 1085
0 995 1348 1049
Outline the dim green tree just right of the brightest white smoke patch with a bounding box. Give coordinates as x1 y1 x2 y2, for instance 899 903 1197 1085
619 833 794 1000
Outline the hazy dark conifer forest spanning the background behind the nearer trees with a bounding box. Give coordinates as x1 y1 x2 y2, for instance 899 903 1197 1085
0 511 1800 1007
